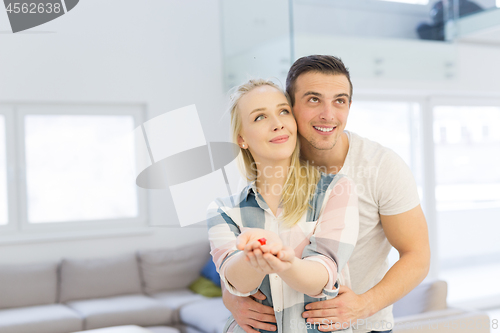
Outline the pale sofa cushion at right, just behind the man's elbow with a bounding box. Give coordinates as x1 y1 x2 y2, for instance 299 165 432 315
392 280 448 317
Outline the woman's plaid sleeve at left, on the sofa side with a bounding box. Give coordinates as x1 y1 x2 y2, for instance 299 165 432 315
207 200 259 297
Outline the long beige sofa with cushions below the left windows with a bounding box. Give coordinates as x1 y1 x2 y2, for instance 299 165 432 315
0 242 229 333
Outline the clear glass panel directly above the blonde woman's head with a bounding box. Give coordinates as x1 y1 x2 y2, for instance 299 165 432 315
221 0 291 91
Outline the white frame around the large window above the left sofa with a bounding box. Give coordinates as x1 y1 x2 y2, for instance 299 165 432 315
0 103 150 243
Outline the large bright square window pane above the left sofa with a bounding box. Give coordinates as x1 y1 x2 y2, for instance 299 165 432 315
24 115 138 223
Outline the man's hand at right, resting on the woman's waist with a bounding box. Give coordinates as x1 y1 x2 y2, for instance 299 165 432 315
302 286 370 332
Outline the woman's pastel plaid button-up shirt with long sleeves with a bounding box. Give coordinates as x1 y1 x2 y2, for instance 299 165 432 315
207 173 359 333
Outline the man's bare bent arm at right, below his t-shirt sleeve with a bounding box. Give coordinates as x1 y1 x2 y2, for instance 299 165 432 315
303 205 430 330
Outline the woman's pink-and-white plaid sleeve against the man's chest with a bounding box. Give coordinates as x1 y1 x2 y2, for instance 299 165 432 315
302 175 359 298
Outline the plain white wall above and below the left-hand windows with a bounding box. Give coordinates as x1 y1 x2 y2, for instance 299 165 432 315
0 0 225 263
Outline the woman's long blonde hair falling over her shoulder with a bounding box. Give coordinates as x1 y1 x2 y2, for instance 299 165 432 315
229 79 320 227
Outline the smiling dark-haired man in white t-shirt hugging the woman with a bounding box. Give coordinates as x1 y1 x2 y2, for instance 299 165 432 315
223 55 430 333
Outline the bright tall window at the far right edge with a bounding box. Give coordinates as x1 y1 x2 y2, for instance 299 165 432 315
433 105 500 303
